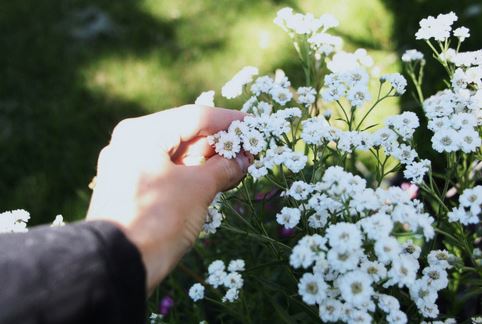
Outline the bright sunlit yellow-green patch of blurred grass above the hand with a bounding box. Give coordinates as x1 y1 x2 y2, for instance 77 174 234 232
82 0 397 119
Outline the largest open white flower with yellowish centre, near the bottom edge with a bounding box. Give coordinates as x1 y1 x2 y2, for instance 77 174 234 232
337 270 373 307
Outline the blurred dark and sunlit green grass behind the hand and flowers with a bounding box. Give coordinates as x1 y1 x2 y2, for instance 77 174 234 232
0 0 482 225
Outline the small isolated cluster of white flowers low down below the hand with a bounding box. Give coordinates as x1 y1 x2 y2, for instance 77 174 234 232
189 259 245 303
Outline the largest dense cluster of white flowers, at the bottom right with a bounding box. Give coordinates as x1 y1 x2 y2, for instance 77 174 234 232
281 167 451 323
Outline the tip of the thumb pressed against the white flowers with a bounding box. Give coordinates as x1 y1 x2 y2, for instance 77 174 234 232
202 152 253 193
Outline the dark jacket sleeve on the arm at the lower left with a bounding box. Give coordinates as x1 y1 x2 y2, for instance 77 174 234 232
0 221 146 324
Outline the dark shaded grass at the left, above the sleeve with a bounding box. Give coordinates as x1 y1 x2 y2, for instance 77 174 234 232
0 0 190 225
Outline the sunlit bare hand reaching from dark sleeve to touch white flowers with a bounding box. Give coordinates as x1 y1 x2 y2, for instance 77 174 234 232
87 105 252 291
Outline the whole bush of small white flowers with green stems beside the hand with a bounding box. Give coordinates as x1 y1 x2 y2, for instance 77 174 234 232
167 8 482 323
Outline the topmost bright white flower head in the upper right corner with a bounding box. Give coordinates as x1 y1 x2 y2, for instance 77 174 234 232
415 12 457 41
